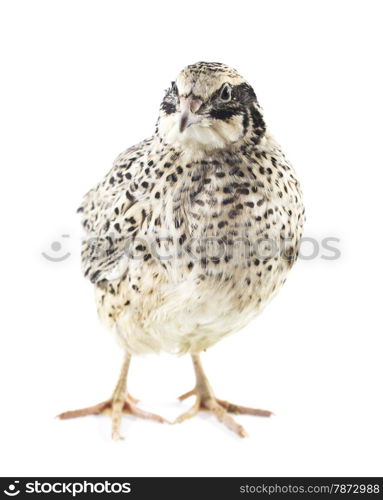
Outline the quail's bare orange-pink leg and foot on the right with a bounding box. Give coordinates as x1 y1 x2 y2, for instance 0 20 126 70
174 354 272 437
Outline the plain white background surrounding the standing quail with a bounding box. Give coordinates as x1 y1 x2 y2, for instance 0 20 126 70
0 0 383 476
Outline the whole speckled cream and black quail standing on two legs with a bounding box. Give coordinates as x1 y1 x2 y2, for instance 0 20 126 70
60 62 304 439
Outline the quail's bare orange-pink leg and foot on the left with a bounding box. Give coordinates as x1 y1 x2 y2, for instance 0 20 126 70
57 354 167 440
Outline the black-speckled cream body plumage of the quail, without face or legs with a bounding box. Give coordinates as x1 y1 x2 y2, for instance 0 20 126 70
81 62 303 353
